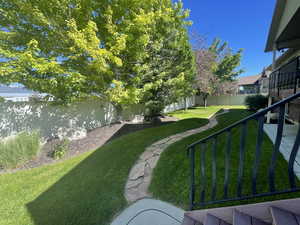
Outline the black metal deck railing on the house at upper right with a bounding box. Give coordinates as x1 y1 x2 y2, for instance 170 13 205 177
269 57 300 96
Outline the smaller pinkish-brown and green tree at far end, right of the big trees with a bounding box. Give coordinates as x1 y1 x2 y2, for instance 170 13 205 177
193 33 243 107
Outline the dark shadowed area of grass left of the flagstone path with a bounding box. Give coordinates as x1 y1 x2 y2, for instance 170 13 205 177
26 119 207 225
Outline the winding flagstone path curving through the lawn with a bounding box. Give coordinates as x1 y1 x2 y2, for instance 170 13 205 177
124 110 229 203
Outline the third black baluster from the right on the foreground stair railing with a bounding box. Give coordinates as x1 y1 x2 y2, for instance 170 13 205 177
252 115 265 195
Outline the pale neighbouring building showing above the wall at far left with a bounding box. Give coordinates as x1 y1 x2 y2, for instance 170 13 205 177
0 85 39 102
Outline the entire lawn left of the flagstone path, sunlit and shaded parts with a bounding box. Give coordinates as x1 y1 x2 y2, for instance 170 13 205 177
0 118 208 225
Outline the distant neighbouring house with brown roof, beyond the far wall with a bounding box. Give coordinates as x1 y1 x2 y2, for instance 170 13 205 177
237 70 270 94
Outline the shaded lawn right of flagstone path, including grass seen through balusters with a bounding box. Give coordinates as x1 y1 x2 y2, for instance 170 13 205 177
150 109 300 209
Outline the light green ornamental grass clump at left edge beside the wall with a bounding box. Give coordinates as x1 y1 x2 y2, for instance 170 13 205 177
0 132 40 169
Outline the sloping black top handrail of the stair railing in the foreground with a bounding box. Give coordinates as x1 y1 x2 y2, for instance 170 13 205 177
188 92 300 150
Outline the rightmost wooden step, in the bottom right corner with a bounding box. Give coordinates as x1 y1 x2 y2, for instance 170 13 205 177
271 206 300 225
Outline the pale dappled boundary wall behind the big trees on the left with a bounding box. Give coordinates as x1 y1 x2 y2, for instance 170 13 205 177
0 98 195 139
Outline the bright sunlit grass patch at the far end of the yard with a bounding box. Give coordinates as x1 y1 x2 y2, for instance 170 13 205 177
168 105 245 119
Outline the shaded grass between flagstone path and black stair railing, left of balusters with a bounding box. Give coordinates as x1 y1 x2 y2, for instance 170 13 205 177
149 109 254 209
